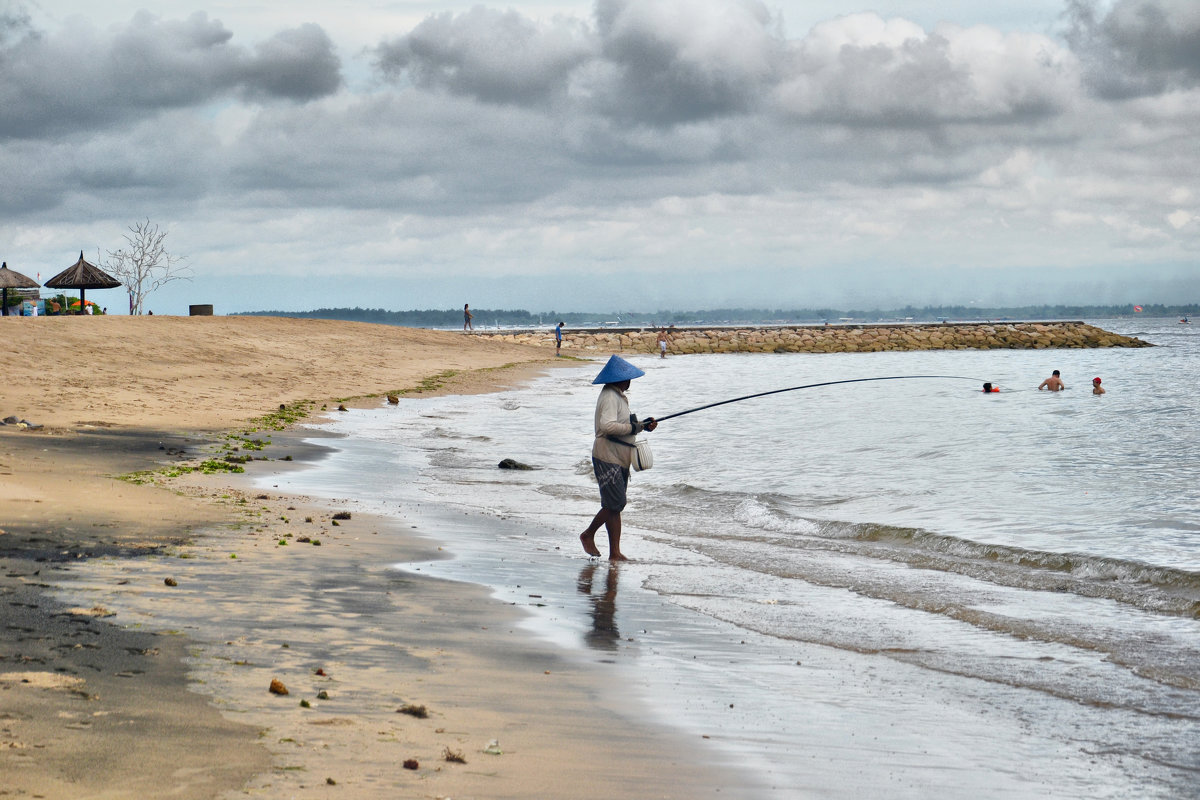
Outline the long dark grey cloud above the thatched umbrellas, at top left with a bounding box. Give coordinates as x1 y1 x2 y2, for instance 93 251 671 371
0 12 341 138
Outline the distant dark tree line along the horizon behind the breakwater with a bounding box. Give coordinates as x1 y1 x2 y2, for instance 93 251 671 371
242 303 1200 329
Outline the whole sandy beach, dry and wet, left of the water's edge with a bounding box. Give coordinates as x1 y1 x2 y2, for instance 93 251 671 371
0 317 737 799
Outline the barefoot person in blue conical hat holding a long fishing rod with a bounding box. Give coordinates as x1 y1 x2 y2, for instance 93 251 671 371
580 355 659 561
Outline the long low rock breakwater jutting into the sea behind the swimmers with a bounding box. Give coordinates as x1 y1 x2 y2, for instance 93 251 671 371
475 321 1153 355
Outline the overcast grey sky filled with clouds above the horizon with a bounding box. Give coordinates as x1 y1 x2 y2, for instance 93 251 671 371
0 0 1200 313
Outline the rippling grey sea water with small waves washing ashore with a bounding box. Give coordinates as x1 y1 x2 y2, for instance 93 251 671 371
271 319 1200 798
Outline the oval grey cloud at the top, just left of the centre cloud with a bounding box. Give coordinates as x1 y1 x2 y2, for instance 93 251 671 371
376 6 594 104
